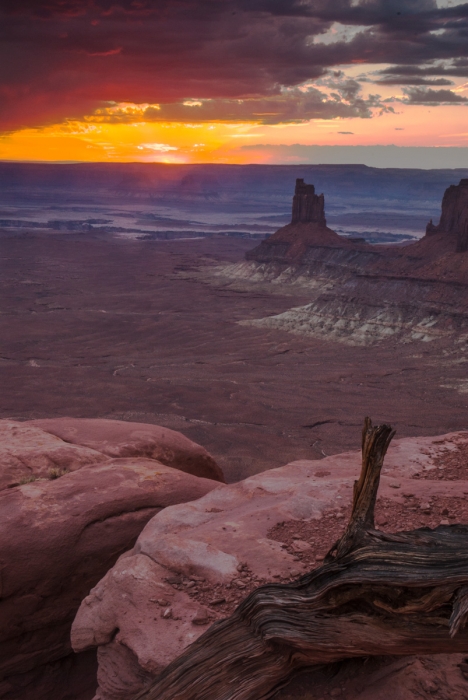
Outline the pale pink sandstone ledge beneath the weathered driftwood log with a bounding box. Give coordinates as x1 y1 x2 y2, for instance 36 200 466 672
72 432 468 700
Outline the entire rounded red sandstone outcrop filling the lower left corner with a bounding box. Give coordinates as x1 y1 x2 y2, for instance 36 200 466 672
0 418 222 700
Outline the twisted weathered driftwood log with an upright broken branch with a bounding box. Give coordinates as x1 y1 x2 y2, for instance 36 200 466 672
133 419 468 700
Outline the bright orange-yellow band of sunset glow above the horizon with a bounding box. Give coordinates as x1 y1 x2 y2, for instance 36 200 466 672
0 104 468 164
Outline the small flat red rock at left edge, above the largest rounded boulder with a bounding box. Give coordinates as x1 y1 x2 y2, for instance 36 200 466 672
0 420 109 491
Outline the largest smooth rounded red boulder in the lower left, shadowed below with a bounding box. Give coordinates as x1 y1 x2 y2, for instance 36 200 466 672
0 458 218 689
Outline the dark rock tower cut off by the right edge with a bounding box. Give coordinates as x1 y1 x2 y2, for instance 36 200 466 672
426 178 468 253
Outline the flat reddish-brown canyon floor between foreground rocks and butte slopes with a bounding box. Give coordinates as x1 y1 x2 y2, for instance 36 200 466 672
0 231 468 482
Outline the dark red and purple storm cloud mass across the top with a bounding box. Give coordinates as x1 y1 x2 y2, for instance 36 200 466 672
0 0 468 128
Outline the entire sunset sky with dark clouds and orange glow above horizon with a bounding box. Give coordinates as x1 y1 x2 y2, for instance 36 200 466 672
0 0 468 167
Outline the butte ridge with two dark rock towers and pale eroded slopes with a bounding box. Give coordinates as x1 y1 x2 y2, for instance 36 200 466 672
214 179 468 345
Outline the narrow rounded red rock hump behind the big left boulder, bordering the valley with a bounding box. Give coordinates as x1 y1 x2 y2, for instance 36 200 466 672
28 418 224 482
